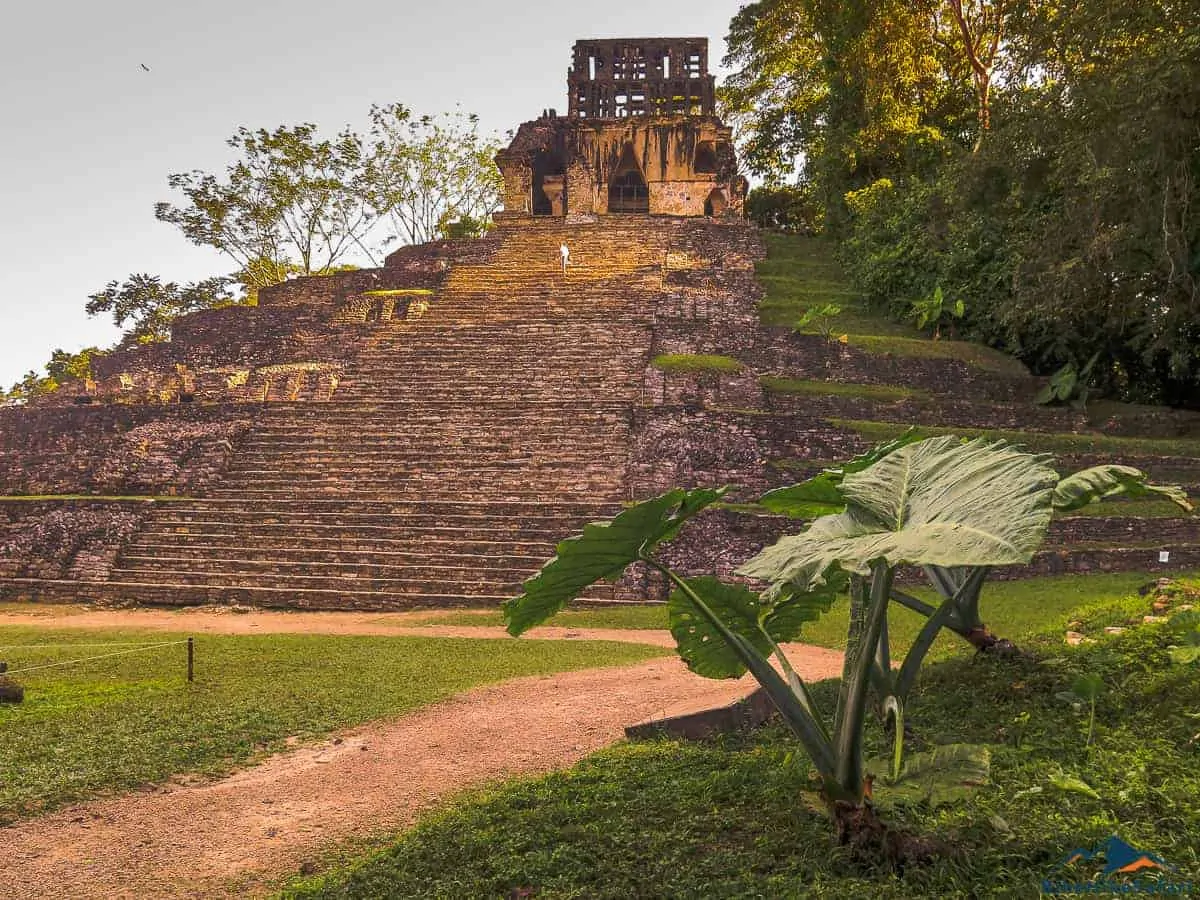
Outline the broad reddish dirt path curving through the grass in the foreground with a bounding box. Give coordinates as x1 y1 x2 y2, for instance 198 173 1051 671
0 648 840 900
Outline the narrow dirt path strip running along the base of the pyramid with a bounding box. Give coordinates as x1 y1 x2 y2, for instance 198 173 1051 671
0 605 674 647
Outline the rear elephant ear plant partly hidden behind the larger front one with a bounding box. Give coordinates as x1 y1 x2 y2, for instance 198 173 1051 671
758 446 1193 655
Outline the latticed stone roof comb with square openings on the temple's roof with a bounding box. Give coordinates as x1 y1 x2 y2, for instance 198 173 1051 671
566 37 715 119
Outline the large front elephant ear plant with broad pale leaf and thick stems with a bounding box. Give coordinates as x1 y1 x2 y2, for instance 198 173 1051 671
504 437 1084 864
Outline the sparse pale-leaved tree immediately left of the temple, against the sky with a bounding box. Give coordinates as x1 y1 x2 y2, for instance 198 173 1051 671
371 103 504 244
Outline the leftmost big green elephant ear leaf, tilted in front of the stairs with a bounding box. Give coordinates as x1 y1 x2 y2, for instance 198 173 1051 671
504 487 728 636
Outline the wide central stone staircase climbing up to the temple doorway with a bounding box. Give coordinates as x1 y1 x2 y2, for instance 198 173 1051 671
7 217 700 608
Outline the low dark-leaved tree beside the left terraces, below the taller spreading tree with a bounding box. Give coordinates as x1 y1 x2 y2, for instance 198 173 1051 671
84 274 235 343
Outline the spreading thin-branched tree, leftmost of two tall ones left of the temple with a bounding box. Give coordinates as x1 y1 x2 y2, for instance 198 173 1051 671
155 124 378 289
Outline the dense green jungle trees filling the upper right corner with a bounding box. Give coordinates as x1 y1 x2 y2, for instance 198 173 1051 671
724 0 1200 408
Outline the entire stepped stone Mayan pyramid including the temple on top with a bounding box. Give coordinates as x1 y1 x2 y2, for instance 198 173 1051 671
0 38 1200 608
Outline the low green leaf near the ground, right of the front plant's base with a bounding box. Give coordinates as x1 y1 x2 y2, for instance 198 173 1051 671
865 744 991 809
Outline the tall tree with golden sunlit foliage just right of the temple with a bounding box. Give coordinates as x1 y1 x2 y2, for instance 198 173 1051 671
722 0 972 213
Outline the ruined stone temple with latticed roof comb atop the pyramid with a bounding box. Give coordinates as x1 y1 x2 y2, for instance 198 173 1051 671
496 37 748 224
